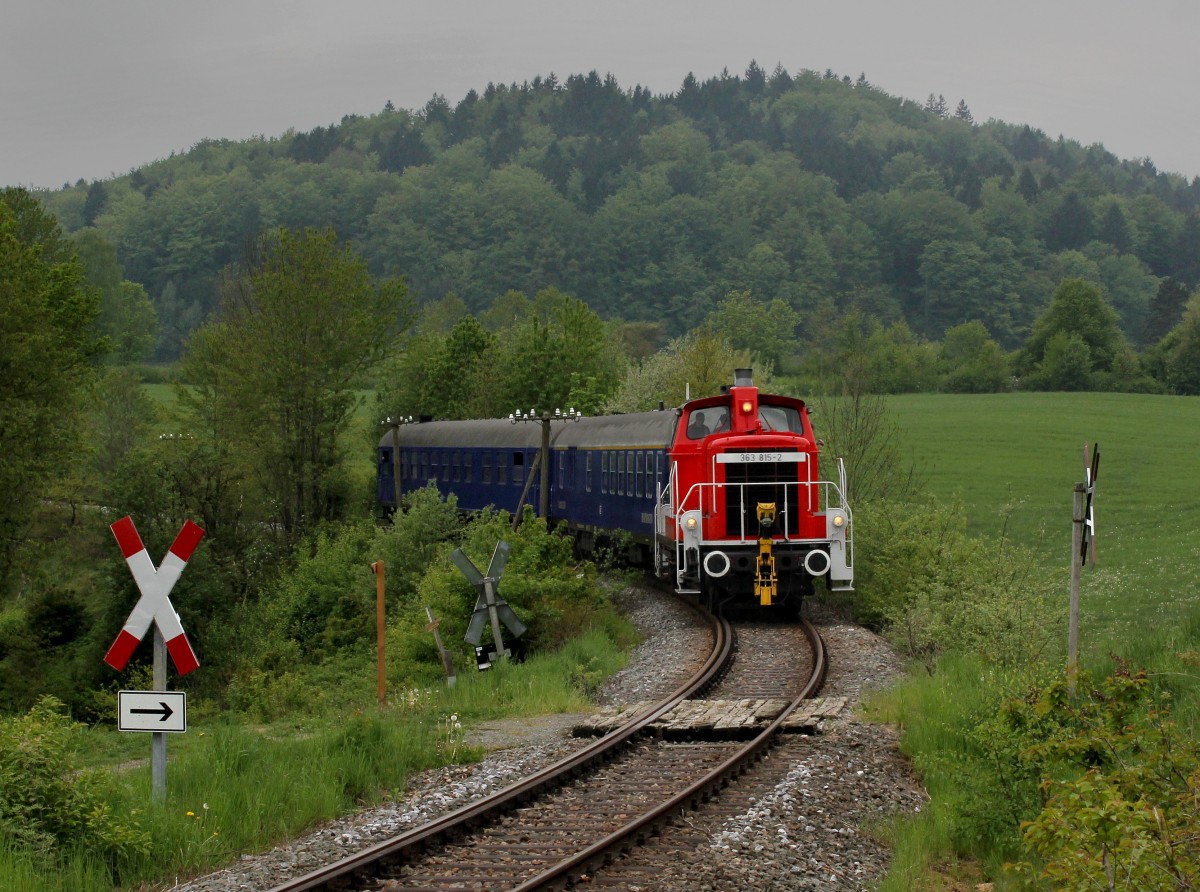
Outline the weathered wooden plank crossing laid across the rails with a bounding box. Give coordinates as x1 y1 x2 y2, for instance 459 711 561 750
571 696 846 741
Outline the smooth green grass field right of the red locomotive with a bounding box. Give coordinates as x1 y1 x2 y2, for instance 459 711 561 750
888 394 1200 667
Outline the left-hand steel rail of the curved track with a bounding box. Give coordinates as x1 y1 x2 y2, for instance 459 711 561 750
270 603 736 892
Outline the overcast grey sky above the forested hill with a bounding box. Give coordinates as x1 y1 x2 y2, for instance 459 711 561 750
0 0 1200 187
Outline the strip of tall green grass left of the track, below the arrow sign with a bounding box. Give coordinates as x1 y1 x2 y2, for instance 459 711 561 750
0 630 625 892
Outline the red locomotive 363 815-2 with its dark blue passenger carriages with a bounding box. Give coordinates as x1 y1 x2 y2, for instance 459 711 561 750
378 369 853 609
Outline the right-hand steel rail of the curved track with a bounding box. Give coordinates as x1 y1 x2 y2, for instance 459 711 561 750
512 619 827 892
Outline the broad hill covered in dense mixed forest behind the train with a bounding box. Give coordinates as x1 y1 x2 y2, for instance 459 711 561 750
32 64 1200 359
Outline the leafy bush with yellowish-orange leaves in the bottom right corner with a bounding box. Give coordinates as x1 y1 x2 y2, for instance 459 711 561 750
1001 664 1200 891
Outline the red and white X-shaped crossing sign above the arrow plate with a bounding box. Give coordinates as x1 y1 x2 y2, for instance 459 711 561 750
104 517 204 675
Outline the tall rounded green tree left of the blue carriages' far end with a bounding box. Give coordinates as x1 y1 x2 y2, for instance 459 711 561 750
184 229 412 538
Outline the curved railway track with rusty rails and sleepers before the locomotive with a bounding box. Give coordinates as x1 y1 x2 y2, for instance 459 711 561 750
265 607 824 892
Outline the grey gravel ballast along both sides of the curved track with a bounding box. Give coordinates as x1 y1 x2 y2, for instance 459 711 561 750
167 592 925 892
